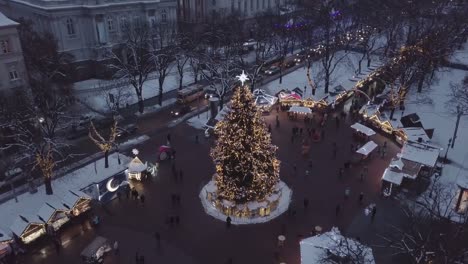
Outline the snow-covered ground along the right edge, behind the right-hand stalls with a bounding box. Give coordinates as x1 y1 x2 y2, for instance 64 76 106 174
382 68 468 219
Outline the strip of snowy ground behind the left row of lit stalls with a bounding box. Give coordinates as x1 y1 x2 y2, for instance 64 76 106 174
0 153 130 235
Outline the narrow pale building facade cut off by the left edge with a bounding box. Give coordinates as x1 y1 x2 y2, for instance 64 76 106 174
0 13 27 93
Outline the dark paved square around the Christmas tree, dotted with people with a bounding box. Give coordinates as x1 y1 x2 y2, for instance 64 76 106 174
13 104 398 264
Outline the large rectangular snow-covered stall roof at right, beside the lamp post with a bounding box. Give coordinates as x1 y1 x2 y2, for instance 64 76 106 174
401 142 440 167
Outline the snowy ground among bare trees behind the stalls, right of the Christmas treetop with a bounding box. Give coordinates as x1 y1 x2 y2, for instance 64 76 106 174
262 51 382 99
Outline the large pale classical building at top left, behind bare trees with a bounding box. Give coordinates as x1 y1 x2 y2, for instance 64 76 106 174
0 0 177 79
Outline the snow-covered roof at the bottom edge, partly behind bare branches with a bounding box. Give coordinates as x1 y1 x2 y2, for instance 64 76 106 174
299 227 375 264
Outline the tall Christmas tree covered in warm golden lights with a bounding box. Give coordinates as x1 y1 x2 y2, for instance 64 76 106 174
211 83 280 204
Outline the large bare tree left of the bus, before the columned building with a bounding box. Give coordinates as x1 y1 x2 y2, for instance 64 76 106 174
108 22 154 113
